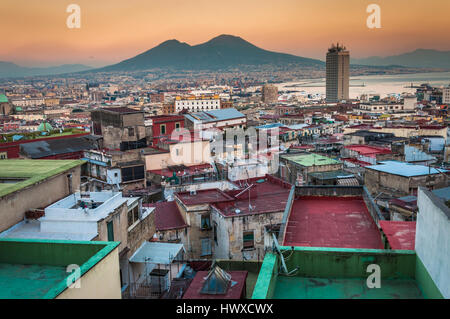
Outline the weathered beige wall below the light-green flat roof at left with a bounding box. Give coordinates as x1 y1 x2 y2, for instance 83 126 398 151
0 166 80 232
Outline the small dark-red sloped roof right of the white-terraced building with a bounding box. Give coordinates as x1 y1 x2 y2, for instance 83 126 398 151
143 201 188 231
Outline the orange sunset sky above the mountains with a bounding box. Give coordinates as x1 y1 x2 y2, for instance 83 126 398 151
0 0 450 66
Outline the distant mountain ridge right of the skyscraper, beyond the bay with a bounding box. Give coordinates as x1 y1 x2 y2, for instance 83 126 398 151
352 49 450 69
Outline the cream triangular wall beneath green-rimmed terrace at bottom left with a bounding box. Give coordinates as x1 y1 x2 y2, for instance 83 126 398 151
56 248 122 299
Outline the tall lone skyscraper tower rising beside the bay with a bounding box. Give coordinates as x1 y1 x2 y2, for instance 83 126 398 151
326 43 350 103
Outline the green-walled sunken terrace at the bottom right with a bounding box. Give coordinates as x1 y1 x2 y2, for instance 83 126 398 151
252 247 442 299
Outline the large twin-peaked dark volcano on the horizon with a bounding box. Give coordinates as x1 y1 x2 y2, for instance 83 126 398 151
96 35 324 71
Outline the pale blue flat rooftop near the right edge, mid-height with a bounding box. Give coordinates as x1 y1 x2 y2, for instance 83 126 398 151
366 161 447 177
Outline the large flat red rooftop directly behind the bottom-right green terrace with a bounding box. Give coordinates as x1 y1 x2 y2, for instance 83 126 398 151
283 196 384 249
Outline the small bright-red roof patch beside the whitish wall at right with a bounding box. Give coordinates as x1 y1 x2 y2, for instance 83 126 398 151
380 220 416 250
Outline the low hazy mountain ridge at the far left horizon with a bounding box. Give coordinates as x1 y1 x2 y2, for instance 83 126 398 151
0 61 92 78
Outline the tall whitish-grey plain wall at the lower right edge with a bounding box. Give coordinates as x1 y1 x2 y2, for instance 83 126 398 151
415 187 450 299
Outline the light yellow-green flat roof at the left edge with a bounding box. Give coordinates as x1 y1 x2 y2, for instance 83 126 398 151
0 159 85 197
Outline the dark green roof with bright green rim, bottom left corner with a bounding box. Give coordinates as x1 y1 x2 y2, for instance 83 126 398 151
0 238 119 299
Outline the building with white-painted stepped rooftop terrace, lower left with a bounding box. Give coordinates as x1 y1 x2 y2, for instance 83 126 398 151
0 191 155 294
